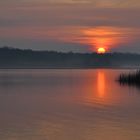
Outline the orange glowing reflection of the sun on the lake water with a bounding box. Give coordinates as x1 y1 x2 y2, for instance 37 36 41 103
78 69 122 106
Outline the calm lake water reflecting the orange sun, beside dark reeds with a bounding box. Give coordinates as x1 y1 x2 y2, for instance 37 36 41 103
0 70 140 140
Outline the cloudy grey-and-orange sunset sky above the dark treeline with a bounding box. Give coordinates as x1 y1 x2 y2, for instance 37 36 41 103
0 0 140 53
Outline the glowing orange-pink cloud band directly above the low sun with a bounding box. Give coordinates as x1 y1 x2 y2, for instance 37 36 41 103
0 26 140 51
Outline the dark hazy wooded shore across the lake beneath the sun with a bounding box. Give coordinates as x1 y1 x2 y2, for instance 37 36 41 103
0 47 140 69
